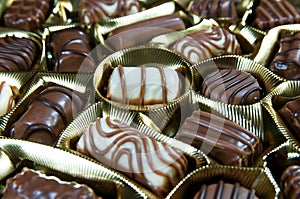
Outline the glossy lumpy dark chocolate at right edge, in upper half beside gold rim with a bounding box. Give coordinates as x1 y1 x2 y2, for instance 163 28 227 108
270 32 300 80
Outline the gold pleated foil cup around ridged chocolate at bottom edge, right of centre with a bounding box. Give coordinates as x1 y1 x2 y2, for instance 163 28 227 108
166 165 279 199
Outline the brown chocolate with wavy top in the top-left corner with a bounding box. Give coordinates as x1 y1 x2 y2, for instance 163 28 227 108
3 0 50 31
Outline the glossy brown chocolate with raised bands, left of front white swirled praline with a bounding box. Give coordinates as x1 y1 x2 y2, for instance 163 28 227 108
10 86 83 145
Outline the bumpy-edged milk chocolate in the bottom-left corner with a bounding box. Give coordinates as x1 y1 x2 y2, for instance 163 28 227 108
2 168 100 199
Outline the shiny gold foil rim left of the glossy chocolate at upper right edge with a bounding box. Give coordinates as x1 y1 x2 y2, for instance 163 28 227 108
254 24 300 80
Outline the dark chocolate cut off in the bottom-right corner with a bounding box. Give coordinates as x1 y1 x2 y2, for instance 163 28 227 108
280 165 300 199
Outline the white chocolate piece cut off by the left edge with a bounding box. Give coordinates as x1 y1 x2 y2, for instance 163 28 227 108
0 82 15 116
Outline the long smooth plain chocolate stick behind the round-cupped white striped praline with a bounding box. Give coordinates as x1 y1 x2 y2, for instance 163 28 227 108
105 13 185 50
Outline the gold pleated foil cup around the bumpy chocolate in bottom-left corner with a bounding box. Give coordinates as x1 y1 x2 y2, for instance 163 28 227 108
0 138 149 198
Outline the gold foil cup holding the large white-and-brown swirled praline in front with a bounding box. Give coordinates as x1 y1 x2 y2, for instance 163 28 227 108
56 101 210 198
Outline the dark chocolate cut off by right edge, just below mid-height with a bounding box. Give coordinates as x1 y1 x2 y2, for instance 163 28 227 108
278 98 300 141
